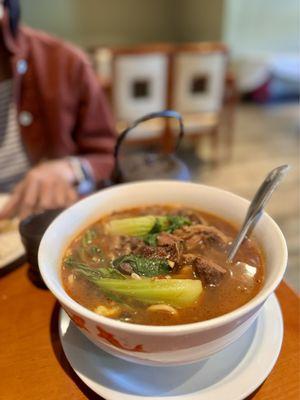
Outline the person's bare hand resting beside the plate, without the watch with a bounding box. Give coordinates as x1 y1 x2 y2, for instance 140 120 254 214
0 160 78 220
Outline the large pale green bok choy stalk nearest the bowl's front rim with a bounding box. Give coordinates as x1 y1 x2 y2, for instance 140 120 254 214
95 278 202 308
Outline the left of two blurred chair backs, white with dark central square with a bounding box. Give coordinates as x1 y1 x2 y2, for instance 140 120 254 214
112 45 169 143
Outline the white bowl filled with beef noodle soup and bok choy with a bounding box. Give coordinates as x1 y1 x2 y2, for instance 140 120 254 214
39 181 287 365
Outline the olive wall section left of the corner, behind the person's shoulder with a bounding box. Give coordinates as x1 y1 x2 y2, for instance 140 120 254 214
21 0 175 47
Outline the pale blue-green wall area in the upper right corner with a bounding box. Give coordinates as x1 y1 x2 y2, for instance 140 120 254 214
223 0 300 55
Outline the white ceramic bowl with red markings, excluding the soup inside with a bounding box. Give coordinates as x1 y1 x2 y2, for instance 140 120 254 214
39 181 287 365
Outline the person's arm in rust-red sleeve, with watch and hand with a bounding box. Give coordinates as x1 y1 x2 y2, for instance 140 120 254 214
0 55 115 219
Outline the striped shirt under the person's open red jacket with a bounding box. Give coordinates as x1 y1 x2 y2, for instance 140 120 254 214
0 80 30 192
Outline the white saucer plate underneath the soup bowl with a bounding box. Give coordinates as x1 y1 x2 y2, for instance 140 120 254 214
59 294 283 400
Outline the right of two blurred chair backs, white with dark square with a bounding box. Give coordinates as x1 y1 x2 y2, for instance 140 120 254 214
171 43 227 161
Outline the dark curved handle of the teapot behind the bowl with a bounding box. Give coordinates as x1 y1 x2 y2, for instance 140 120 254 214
114 110 184 182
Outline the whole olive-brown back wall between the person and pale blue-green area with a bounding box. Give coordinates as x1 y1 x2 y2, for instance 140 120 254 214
21 0 224 47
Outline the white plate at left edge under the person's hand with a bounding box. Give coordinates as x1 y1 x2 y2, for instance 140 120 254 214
0 193 25 269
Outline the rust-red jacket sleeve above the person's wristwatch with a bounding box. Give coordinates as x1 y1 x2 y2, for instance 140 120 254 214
75 61 116 182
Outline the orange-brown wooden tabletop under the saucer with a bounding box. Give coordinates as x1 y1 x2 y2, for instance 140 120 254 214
0 264 300 400
